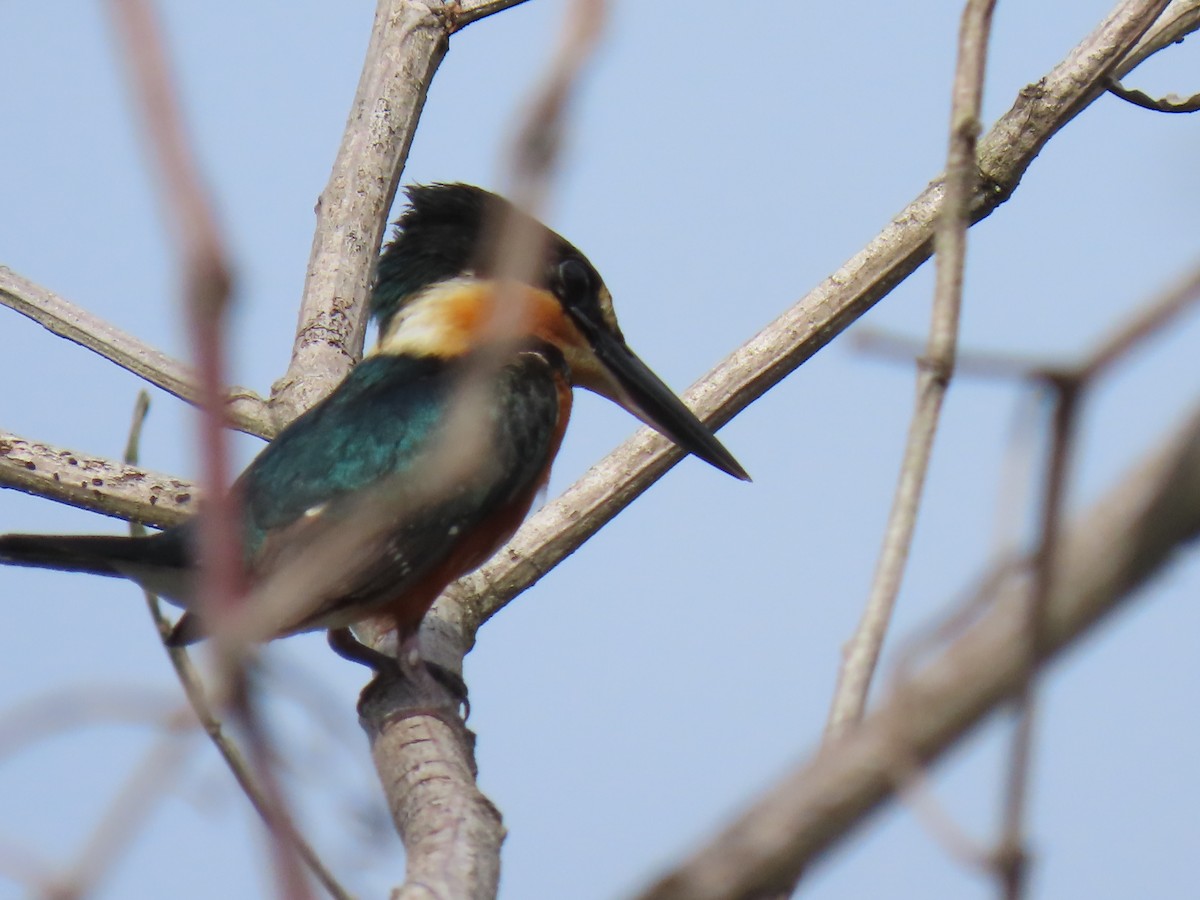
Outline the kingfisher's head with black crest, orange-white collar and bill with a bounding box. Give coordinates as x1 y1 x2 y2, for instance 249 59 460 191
371 184 749 480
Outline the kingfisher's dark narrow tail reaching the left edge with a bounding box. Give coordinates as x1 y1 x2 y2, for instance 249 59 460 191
0 534 181 578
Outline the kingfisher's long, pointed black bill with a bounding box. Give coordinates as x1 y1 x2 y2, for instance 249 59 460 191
589 331 750 481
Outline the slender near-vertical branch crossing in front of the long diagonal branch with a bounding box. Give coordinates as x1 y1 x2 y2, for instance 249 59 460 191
826 0 996 738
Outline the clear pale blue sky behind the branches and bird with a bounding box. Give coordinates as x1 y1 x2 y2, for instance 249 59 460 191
0 0 1200 900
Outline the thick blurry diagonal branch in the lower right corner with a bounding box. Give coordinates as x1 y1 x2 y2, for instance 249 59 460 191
640 400 1200 900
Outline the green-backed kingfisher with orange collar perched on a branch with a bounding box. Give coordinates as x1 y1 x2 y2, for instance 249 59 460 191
0 184 749 668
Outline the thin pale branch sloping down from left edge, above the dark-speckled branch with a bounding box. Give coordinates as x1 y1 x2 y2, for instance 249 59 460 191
0 265 275 438
